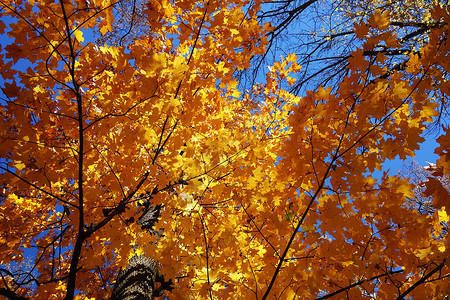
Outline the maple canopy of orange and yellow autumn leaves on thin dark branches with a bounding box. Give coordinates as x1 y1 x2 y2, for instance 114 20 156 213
0 0 450 299
